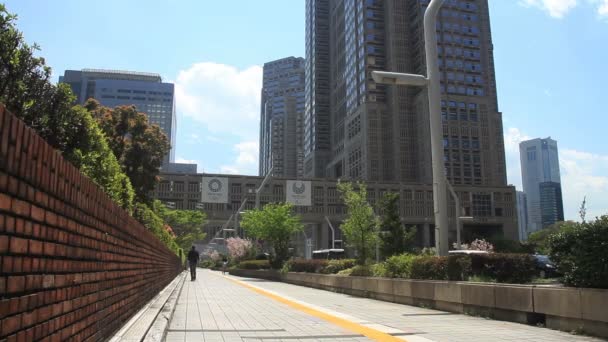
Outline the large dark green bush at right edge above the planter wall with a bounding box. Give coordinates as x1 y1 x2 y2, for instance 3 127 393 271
548 215 608 289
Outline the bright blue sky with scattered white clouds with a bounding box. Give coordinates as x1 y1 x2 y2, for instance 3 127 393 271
0 0 608 220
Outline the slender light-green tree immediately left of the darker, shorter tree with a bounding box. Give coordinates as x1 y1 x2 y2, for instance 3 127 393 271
338 182 378 265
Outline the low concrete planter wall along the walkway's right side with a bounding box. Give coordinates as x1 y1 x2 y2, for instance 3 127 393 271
230 270 608 338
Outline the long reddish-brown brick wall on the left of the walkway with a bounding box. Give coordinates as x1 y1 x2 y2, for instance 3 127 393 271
0 105 180 341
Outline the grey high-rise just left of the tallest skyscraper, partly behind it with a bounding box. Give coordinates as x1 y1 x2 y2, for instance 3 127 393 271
259 57 304 178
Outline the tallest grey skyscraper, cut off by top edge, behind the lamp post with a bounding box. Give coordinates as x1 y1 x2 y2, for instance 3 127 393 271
304 0 507 187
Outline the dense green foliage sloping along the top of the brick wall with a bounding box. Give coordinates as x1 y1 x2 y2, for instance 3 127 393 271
0 4 133 212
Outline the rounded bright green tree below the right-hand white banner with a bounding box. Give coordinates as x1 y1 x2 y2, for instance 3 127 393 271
241 203 304 269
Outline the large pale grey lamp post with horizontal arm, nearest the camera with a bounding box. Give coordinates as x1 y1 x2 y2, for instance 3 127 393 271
372 0 449 255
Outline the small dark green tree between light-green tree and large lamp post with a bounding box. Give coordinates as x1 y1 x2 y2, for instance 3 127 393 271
380 192 416 258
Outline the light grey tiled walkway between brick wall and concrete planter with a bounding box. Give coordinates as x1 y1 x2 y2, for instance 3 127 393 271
166 269 600 342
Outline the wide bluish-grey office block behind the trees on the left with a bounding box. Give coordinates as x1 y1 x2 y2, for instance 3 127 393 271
59 69 177 165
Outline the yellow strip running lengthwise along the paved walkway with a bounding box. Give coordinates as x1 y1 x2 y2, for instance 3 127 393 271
221 275 430 342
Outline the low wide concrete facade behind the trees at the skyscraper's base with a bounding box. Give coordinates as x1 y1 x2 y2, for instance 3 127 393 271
152 173 518 255
